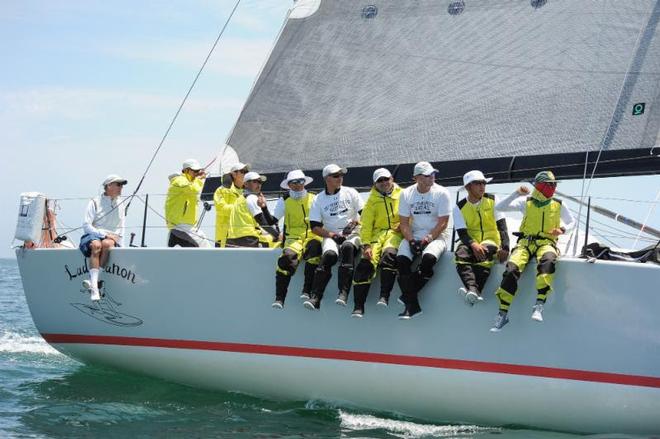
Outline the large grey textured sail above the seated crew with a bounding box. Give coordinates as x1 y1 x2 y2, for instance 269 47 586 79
227 0 660 182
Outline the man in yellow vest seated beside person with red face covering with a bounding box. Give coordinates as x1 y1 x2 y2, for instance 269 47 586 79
453 171 509 305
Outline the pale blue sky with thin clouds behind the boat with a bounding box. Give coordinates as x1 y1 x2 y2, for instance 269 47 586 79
0 0 660 258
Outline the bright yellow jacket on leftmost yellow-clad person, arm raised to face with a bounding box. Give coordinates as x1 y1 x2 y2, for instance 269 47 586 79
165 174 204 229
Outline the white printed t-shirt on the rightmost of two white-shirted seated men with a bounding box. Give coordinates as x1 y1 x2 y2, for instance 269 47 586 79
399 183 451 240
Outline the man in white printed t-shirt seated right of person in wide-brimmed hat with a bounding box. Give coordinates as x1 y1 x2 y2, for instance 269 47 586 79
304 163 364 310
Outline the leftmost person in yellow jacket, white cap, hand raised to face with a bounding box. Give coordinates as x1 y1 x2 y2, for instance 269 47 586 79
165 159 208 247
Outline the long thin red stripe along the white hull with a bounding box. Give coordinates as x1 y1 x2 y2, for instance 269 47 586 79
41 334 660 388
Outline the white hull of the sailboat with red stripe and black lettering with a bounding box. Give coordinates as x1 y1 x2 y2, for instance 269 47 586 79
17 248 660 434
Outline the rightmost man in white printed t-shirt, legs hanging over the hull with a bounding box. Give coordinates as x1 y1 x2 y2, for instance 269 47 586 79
397 162 451 320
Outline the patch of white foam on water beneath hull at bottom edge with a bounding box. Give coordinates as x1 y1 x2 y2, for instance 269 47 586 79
339 410 501 439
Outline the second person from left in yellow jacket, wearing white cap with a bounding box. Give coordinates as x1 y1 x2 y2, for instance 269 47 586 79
213 162 250 247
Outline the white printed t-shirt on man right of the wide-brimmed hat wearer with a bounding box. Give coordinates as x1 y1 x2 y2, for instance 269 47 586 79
309 186 364 233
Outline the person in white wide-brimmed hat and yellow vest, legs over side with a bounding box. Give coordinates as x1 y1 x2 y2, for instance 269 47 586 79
273 169 321 309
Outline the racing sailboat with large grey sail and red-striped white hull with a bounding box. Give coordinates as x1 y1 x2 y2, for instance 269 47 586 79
11 0 660 434
